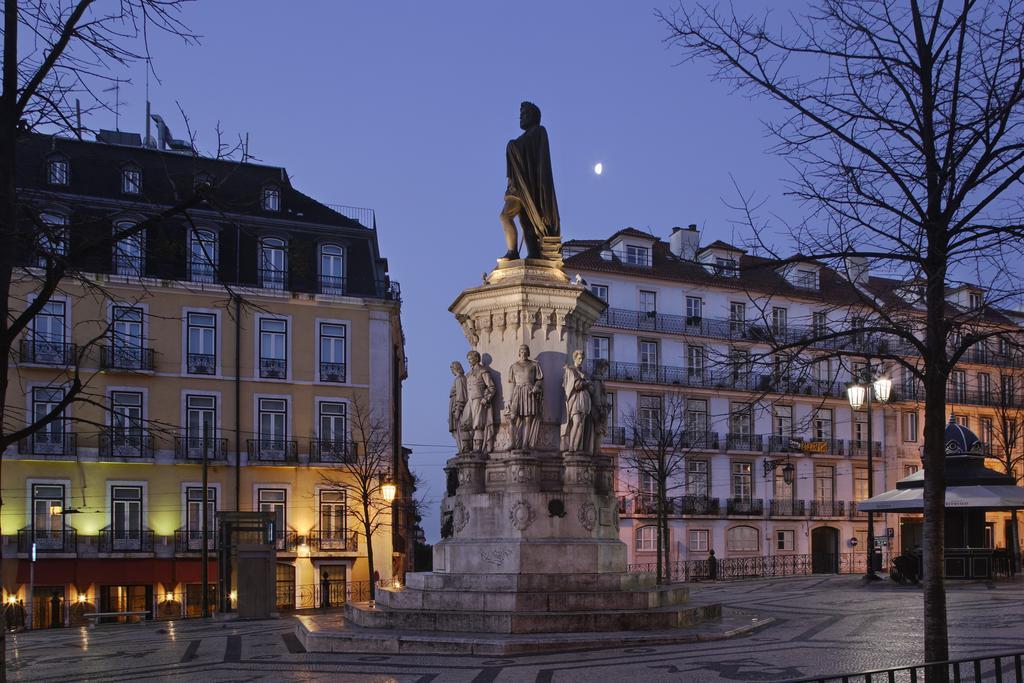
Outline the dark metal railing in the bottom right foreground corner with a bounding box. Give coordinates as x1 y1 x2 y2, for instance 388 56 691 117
786 652 1024 683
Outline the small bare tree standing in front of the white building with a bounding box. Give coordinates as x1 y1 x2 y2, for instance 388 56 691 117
620 393 709 584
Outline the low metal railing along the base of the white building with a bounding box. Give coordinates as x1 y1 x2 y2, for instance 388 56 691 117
627 552 888 582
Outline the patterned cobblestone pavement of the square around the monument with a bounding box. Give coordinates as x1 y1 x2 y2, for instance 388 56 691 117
7 577 1024 683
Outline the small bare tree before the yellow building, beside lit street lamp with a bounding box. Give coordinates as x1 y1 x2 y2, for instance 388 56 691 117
323 398 401 600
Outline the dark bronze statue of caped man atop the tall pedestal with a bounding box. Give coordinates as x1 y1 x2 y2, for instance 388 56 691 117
501 102 561 260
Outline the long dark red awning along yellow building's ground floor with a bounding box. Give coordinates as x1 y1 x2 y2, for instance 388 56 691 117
17 558 217 587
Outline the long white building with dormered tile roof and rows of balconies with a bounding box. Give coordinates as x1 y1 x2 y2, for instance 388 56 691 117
564 225 1024 566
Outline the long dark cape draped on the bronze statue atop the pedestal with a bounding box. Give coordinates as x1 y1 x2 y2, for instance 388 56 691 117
505 126 561 238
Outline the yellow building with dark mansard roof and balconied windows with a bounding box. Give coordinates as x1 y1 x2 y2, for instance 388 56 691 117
0 132 410 627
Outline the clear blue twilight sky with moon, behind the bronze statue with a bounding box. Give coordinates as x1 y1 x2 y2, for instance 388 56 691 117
105 0 799 541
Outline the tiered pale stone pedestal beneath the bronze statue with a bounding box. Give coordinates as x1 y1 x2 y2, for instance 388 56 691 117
346 260 721 634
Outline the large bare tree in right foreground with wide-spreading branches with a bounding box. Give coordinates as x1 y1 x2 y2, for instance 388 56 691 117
662 0 1024 680
